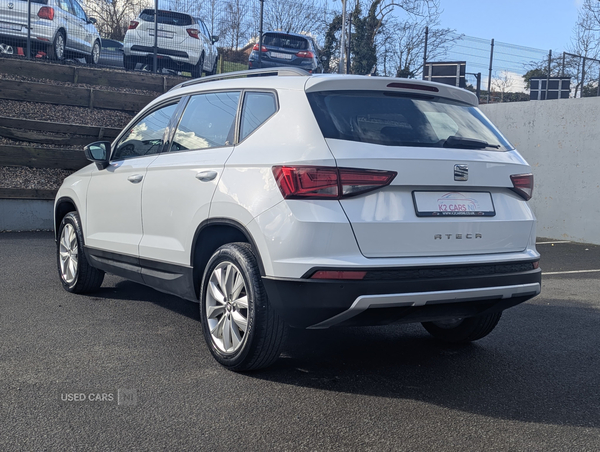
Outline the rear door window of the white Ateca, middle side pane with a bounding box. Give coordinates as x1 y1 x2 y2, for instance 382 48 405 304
171 91 240 151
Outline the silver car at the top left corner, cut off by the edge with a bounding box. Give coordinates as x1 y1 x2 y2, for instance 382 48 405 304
0 0 102 64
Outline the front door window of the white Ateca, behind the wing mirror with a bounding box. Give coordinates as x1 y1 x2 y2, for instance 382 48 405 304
112 104 177 160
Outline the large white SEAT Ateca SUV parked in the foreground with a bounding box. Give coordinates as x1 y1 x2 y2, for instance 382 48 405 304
55 68 541 371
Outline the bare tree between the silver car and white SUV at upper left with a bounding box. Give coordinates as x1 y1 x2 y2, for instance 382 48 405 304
83 0 153 41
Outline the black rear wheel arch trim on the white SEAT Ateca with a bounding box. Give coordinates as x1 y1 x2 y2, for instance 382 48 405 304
190 218 265 297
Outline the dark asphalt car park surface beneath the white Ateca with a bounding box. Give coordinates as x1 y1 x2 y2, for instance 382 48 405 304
0 233 600 451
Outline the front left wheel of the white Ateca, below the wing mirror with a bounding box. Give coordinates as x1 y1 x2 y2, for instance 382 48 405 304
56 212 104 293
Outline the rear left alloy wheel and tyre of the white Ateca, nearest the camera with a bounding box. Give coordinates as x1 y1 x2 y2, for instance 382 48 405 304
200 243 287 372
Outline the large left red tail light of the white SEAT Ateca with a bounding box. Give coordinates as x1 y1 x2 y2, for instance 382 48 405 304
273 166 398 199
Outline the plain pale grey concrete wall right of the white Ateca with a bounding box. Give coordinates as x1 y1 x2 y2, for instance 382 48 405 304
481 98 600 244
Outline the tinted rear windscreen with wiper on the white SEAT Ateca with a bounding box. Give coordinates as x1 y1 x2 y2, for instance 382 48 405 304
307 91 513 150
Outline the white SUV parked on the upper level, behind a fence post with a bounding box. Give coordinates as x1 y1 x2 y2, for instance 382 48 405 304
123 9 219 77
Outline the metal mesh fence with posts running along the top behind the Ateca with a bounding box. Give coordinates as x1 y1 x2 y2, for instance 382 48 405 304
0 0 600 98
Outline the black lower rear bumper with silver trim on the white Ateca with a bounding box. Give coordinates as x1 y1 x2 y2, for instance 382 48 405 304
263 266 541 328
